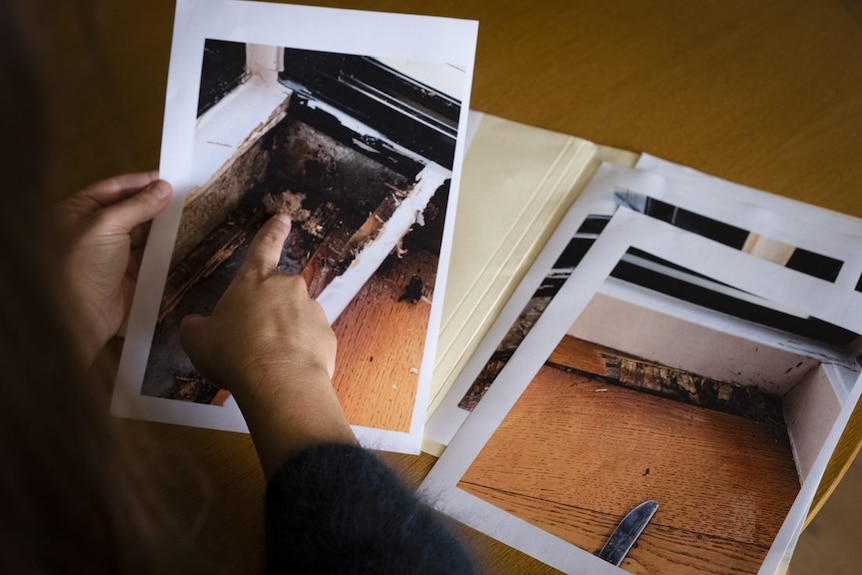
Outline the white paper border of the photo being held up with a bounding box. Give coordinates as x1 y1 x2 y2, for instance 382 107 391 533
111 0 478 453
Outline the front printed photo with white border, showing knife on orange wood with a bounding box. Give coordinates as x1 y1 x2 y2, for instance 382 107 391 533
422 210 860 575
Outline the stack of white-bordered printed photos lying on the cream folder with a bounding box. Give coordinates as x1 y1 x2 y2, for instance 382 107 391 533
420 110 862 574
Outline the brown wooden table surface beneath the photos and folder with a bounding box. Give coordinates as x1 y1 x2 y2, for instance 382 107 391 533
30 0 862 573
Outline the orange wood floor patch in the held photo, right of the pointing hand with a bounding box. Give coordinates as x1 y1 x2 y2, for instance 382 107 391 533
332 252 437 432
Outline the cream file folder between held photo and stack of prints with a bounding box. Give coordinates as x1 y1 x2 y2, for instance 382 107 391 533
428 111 639 426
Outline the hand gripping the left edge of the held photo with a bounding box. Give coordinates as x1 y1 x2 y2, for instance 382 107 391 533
56 172 173 363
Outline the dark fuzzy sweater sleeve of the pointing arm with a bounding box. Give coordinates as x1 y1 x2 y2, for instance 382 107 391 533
266 445 474 575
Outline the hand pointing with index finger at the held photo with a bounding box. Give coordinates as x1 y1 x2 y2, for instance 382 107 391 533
180 215 356 477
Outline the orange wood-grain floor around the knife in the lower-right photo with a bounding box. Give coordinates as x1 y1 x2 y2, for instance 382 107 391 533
459 342 799 573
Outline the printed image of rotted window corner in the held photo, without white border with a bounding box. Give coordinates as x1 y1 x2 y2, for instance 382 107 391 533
141 40 465 430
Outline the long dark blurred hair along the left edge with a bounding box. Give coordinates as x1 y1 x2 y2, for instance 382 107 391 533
0 0 216 574
